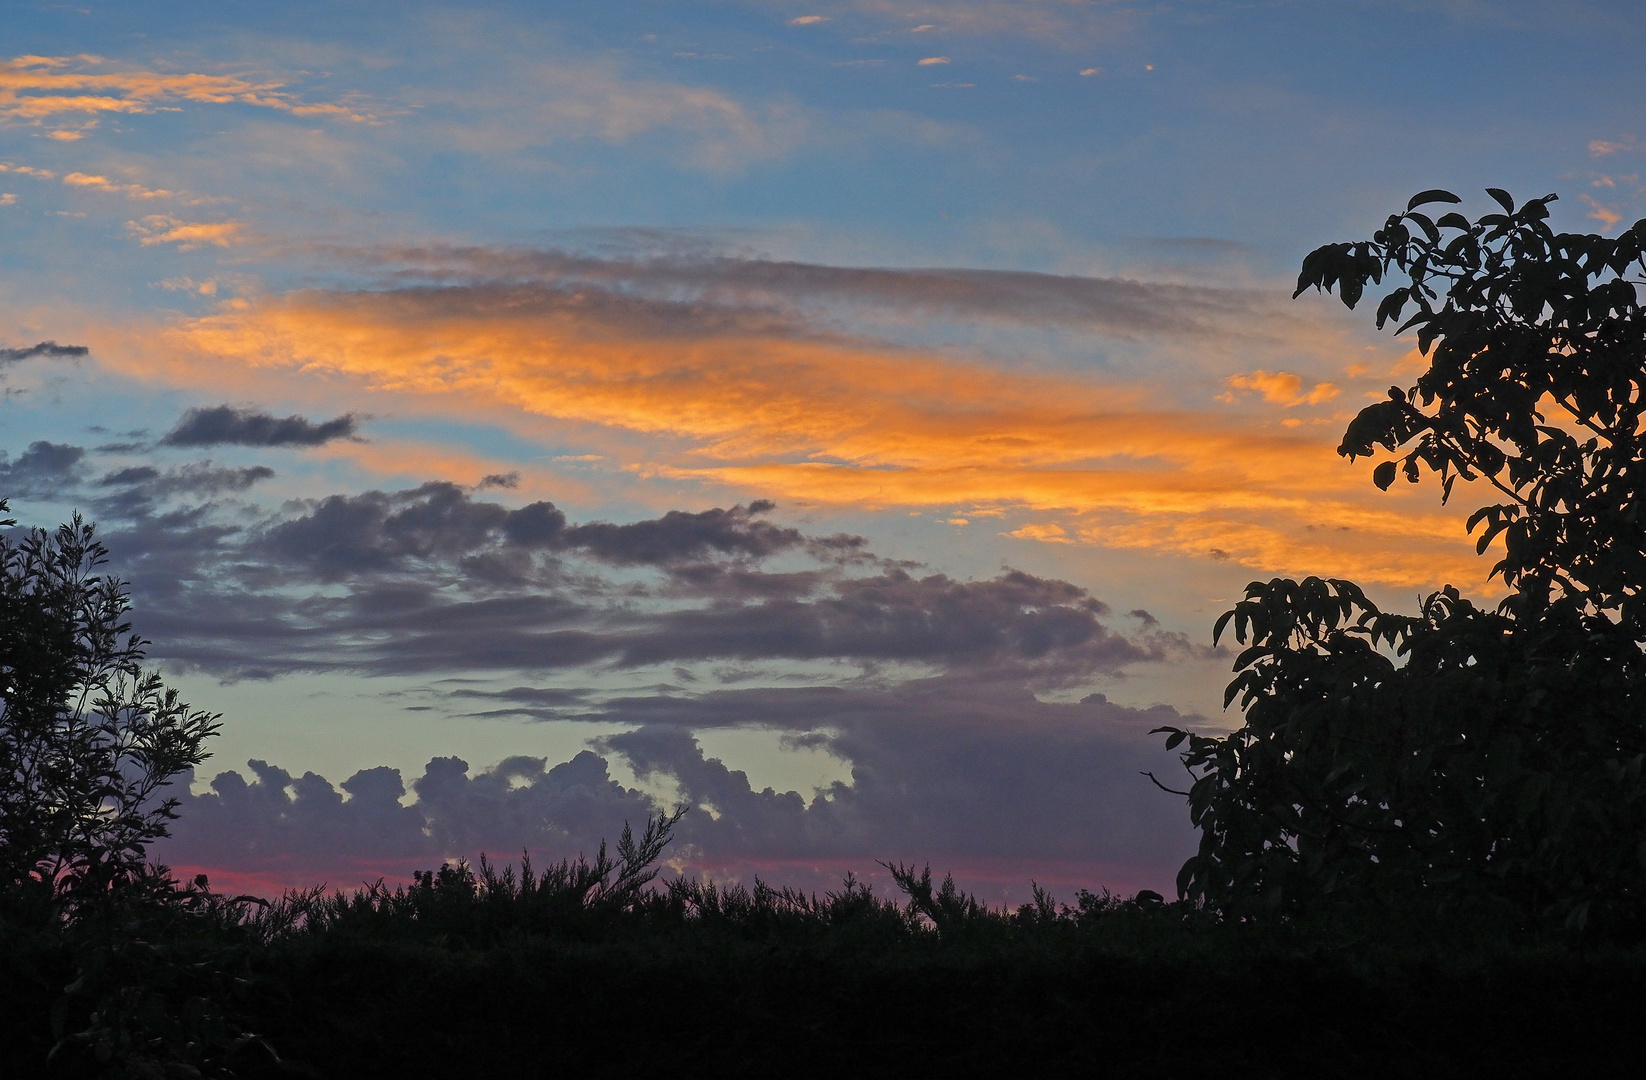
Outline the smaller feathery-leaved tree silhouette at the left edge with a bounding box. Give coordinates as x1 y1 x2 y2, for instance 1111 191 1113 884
0 500 217 897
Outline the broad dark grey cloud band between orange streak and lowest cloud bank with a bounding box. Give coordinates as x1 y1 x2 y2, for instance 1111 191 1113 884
60 474 1188 684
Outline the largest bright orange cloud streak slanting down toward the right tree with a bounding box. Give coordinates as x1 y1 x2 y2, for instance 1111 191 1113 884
96 286 1485 588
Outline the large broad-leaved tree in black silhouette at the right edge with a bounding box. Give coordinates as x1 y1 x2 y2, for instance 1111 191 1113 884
1162 189 1646 930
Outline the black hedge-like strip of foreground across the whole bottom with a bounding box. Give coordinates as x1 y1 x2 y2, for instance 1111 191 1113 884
0 891 1646 1080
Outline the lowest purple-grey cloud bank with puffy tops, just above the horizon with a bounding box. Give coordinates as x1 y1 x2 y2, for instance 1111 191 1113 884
158 680 1193 901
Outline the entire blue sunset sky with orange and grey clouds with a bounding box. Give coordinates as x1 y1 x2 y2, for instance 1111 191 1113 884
0 0 1646 902
